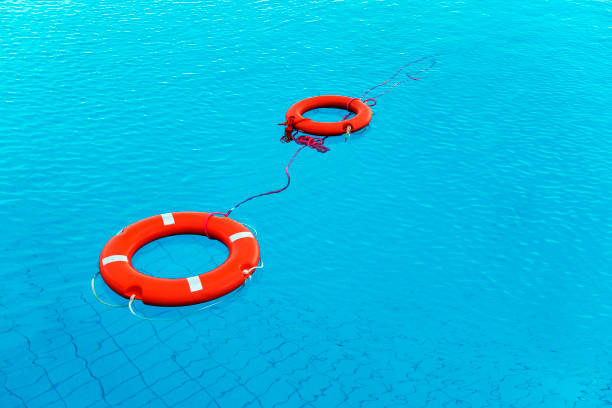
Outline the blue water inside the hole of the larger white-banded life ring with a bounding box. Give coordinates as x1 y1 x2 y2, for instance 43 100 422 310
132 234 229 279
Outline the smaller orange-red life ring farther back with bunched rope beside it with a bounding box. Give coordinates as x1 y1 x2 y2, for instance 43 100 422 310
286 95 372 136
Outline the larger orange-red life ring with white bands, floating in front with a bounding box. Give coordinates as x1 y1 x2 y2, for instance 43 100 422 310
99 212 259 306
